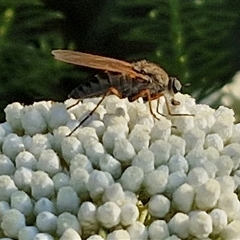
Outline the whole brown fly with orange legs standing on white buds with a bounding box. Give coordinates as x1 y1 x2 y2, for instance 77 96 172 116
52 50 193 135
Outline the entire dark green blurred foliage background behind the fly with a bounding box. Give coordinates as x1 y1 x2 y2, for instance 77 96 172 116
0 0 240 121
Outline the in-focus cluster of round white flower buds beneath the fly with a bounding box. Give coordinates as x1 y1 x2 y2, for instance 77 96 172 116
0 94 240 240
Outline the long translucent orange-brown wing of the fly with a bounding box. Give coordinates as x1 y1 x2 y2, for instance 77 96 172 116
52 50 148 81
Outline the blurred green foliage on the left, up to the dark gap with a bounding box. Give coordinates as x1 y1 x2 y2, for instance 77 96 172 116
0 0 79 119
